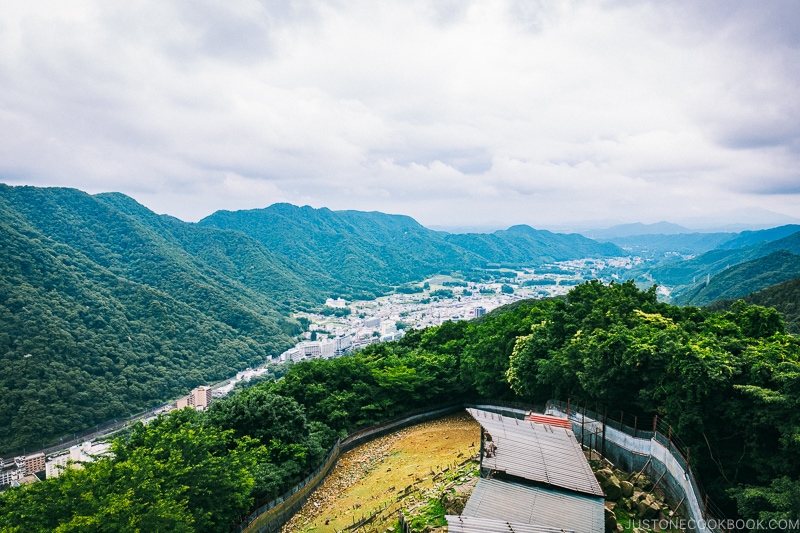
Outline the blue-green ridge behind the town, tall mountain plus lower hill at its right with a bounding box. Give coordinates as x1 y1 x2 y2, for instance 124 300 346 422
199 204 624 296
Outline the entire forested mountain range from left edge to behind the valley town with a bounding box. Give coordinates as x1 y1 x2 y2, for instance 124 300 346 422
0 184 623 453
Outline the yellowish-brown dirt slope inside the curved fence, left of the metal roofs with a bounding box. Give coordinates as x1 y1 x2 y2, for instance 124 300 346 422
282 413 480 533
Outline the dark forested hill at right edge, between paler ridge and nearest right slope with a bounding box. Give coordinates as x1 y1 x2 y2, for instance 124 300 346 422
678 250 800 306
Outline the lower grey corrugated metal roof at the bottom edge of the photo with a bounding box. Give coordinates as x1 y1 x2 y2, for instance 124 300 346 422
460 479 605 533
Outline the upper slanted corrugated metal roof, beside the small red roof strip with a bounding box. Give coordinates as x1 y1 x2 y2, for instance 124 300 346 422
467 409 603 496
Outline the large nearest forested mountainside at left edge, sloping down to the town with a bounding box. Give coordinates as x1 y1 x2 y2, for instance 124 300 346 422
0 186 310 452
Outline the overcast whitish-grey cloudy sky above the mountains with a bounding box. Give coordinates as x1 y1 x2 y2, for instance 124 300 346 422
0 0 800 228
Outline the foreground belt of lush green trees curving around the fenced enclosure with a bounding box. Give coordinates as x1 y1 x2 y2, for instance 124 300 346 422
0 282 800 533
